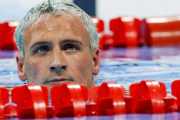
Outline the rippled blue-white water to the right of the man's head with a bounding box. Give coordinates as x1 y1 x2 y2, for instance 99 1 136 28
95 58 180 90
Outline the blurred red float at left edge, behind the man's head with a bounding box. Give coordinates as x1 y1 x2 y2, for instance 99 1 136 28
0 22 19 50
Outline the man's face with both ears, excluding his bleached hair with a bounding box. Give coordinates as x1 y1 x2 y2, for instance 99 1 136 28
16 14 100 88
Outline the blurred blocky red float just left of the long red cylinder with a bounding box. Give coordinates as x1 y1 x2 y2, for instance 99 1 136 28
110 17 143 47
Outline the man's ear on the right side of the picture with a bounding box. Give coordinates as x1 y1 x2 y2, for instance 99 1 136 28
92 48 100 75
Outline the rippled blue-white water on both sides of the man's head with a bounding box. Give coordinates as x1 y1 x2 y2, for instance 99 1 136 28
0 56 180 90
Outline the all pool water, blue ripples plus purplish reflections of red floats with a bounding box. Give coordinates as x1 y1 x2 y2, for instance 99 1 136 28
0 46 180 120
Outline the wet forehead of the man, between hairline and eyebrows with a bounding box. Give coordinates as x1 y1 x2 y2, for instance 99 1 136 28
23 13 89 41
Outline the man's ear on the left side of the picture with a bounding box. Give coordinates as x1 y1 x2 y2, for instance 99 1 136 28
16 54 27 81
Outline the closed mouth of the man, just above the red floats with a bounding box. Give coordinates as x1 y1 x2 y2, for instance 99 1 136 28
44 78 74 86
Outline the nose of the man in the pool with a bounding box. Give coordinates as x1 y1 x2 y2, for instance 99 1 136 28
49 49 67 74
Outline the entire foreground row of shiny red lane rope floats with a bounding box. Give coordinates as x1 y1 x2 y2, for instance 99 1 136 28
0 80 180 119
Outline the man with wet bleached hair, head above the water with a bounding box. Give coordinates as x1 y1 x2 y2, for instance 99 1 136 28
15 0 100 89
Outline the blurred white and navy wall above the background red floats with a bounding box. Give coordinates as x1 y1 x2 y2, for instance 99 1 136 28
0 0 180 31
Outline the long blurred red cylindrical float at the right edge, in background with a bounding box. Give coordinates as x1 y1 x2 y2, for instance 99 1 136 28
142 16 180 46
